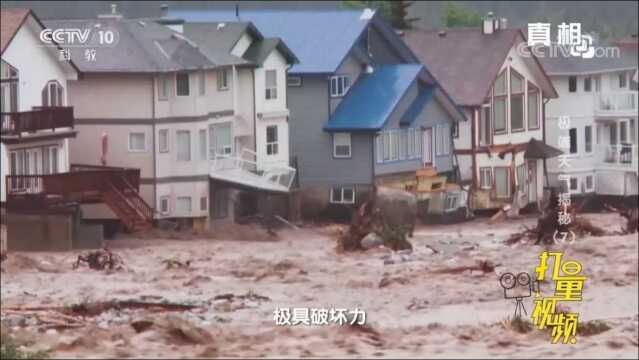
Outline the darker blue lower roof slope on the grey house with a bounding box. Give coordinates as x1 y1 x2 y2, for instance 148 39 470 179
324 64 423 131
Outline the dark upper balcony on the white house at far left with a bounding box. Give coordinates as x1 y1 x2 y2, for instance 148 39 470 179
0 106 74 138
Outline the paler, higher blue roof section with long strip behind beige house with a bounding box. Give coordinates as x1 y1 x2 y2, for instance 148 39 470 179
168 8 370 73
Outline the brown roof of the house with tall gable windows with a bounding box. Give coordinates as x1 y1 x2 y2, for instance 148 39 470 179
404 28 557 106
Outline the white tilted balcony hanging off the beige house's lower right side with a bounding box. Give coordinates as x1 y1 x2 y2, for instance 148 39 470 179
209 149 295 193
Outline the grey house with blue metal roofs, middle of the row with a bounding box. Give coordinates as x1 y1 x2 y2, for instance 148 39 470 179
169 8 464 216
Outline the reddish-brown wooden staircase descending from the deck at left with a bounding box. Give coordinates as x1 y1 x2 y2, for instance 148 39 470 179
102 176 153 232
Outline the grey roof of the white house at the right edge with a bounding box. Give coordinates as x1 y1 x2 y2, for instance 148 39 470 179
539 49 638 75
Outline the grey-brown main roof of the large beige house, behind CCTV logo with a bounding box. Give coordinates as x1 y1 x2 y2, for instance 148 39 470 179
46 18 246 73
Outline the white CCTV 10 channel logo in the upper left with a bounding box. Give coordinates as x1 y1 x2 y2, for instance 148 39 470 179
40 28 120 47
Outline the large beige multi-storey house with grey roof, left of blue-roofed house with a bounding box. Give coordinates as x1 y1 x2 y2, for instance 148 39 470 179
47 7 297 228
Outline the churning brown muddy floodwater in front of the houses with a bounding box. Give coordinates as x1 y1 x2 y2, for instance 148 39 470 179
1 214 638 358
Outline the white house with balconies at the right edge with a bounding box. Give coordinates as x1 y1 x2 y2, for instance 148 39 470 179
541 48 639 202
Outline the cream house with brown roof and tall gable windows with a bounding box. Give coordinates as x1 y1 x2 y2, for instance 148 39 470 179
404 15 557 209
